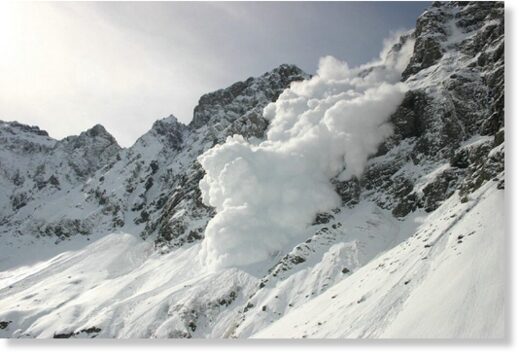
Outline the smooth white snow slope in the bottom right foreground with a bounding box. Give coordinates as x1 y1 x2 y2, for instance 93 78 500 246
254 182 506 339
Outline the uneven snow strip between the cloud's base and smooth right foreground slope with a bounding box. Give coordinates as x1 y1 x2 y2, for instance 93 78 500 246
233 202 423 338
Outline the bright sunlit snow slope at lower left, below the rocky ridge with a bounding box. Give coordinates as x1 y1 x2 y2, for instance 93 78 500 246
0 234 253 338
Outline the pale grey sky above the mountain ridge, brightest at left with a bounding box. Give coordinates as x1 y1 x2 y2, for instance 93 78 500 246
0 2 429 146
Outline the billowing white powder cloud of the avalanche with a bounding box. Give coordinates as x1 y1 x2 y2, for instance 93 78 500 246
198 36 413 269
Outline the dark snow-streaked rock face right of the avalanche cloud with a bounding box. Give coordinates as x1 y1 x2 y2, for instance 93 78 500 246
352 2 504 217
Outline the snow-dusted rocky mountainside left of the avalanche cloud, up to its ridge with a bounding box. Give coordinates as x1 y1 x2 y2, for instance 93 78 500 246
0 65 308 253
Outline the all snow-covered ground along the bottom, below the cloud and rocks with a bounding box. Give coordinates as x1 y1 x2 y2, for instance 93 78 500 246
0 177 506 338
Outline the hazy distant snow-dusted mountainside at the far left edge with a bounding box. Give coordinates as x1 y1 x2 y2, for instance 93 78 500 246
0 121 121 242
